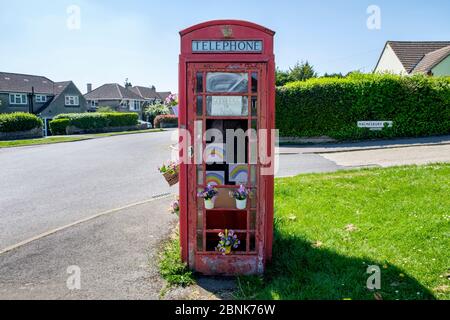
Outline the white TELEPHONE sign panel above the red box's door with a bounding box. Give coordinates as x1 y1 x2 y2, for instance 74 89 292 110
192 40 263 53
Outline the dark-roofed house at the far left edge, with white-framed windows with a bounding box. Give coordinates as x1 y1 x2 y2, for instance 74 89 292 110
0 72 87 131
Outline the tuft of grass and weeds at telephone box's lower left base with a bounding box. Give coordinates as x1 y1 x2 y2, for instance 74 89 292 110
159 230 194 287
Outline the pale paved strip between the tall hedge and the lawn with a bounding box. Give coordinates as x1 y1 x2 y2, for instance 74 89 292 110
277 136 450 177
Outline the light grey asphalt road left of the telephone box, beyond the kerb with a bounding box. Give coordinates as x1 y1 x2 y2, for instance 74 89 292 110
0 131 178 251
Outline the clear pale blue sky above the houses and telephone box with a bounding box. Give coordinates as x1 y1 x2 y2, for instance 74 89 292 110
0 0 450 93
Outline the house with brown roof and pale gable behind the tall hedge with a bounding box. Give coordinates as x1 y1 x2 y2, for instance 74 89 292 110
374 41 450 76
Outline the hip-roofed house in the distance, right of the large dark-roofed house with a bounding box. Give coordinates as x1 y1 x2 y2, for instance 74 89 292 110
84 83 145 119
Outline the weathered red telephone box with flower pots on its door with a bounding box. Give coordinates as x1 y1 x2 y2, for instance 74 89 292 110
179 20 275 275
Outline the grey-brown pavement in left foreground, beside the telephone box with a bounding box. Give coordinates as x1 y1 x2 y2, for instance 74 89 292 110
0 197 177 300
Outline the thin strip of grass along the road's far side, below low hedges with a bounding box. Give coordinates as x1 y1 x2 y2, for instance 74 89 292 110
0 129 163 148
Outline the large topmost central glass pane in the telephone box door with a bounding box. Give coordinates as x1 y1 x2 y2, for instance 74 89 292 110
206 72 248 93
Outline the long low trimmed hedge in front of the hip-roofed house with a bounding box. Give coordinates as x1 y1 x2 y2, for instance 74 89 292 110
50 112 139 132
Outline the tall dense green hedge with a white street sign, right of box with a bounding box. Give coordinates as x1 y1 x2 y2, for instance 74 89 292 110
276 75 450 140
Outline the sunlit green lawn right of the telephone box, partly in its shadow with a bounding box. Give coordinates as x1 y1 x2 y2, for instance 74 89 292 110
238 164 450 300
